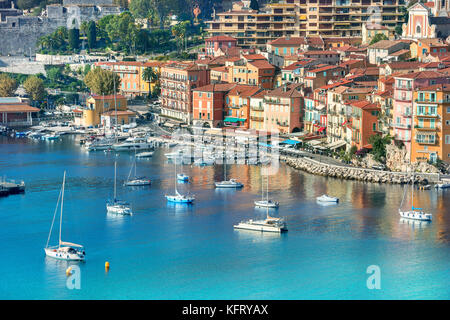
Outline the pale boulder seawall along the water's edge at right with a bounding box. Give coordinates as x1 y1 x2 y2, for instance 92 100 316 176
280 156 439 184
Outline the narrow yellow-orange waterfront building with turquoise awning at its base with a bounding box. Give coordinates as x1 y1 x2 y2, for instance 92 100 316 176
224 85 262 129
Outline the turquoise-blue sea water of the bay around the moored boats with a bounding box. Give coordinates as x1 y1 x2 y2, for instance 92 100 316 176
0 137 450 299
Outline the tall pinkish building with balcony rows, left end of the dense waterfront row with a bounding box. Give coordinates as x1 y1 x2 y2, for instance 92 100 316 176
160 62 210 124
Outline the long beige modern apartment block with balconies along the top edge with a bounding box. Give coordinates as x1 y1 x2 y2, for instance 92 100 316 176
206 0 403 48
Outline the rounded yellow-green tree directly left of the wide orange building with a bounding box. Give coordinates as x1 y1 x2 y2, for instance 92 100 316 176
84 68 120 95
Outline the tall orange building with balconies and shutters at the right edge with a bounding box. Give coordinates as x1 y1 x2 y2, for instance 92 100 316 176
411 84 450 163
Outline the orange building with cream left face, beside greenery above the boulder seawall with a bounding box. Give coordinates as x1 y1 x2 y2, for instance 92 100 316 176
350 100 380 150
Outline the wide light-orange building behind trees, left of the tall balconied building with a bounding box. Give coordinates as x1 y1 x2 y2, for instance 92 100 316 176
95 61 163 97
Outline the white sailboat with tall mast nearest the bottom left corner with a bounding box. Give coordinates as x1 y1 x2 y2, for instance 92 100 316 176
44 171 86 261
